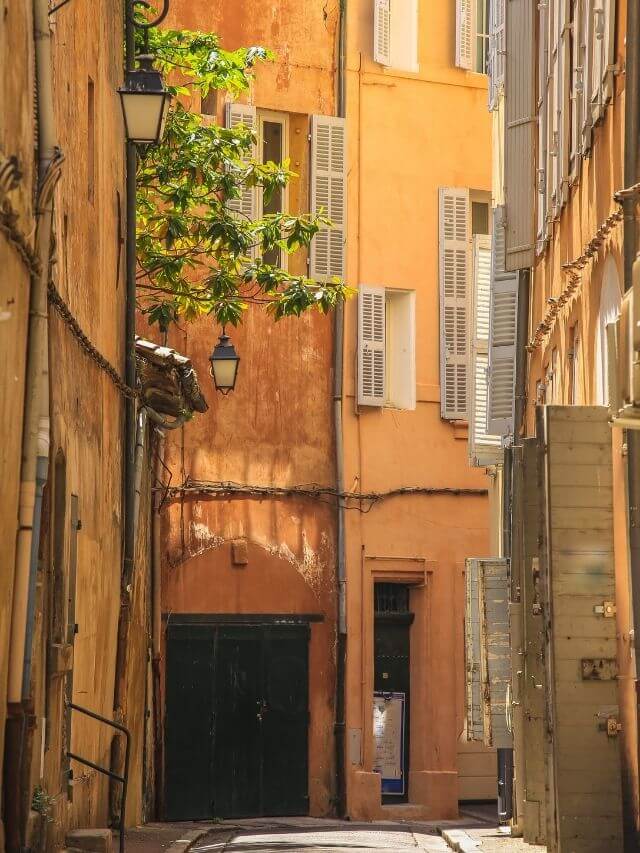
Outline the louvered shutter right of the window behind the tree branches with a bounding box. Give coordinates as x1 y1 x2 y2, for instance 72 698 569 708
309 115 347 281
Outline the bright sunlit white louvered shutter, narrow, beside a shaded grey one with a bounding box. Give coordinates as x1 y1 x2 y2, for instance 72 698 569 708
469 235 502 467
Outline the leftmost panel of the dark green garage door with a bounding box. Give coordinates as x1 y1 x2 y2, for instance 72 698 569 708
165 625 213 820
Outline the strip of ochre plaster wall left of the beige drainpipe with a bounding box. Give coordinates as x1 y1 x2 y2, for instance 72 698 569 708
0 0 35 850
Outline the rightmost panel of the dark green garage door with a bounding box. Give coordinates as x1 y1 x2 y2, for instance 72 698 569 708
262 627 309 815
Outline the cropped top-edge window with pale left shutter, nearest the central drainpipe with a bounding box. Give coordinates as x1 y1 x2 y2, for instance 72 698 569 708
373 0 418 71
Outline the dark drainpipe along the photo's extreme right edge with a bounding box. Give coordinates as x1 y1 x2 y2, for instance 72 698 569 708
623 2 640 849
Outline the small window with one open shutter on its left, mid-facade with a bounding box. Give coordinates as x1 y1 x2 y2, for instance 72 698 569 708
358 285 416 409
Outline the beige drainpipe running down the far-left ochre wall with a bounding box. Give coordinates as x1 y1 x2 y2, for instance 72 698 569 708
4 0 63 849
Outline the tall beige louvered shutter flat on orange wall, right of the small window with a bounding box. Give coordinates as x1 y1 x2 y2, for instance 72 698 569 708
440 187 471 420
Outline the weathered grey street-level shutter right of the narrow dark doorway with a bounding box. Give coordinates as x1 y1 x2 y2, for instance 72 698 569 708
479 558 513 749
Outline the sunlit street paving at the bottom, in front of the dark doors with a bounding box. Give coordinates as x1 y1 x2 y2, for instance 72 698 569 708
190 820 449 853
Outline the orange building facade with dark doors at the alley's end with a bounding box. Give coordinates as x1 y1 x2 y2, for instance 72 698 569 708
159 0 495 819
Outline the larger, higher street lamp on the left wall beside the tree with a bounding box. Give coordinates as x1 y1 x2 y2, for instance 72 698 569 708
118 54 171 145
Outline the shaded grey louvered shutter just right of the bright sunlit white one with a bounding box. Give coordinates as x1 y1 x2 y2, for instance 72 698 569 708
487 207 518 435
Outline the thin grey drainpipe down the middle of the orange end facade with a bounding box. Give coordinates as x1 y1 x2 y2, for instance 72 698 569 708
333 0 347 817
